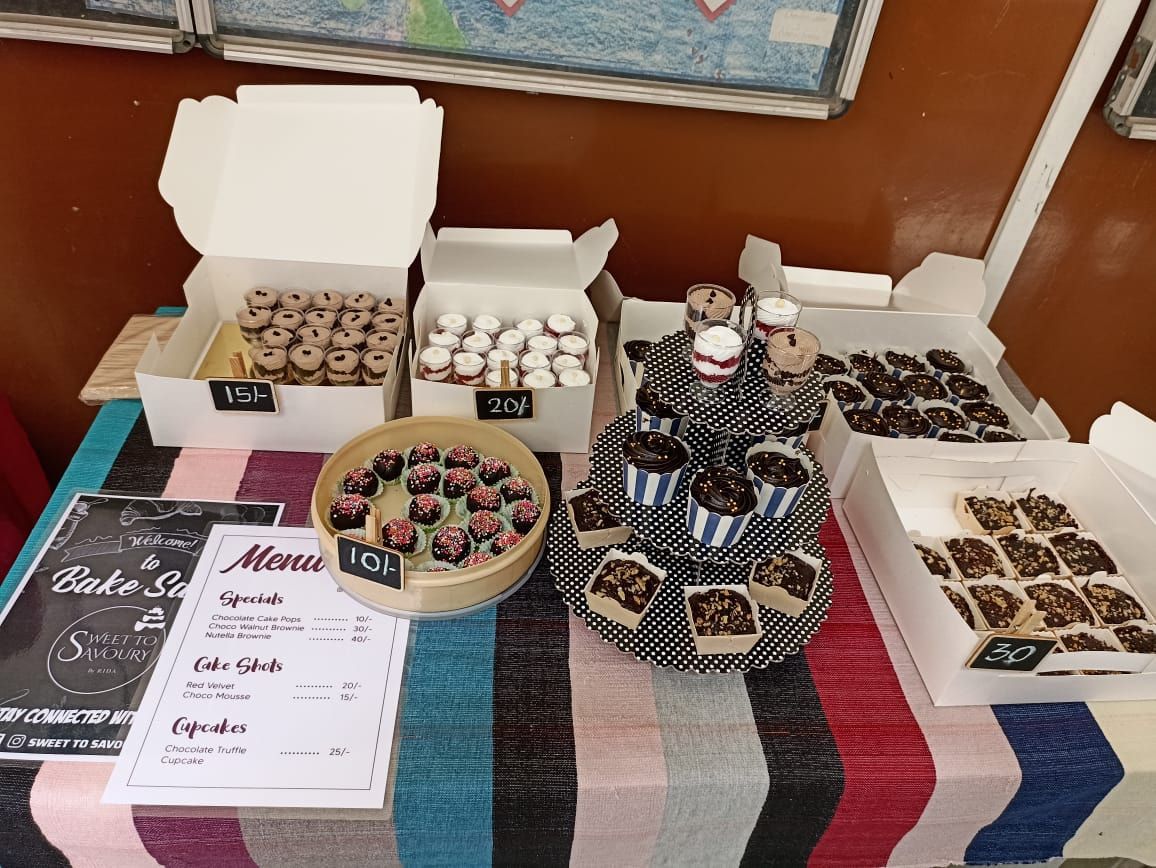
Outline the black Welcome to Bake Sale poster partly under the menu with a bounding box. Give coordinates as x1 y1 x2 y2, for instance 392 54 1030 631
0 494 282 761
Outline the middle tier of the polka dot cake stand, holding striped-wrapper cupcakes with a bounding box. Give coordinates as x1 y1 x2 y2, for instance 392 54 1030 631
591 414 831 570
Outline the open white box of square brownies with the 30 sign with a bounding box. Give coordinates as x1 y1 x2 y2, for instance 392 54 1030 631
844 403 1156 705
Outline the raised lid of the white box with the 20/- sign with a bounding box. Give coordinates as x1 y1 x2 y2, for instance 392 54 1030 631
422 220 618 292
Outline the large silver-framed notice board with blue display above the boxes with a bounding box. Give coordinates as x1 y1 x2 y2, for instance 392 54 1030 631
192 0 883 118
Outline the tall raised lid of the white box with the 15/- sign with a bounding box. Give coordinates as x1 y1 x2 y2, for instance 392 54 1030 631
160 86 442 268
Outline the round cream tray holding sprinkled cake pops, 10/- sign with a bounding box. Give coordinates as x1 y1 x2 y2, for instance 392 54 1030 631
311 416 550 614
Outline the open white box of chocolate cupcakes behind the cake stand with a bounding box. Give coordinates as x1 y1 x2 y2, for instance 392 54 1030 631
616 236 1068 497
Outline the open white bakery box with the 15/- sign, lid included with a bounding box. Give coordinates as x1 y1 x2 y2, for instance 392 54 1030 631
136 86 443 452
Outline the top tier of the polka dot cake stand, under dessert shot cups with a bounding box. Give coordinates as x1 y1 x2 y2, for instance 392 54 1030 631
646 332 823 435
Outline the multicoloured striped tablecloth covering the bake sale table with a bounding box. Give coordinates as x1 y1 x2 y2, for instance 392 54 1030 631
0 401 1156 868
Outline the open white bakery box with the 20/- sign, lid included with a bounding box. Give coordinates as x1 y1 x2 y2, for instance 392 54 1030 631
409 220 618 452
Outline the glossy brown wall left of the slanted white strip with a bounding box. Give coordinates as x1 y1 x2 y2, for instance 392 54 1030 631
0 0 1095 483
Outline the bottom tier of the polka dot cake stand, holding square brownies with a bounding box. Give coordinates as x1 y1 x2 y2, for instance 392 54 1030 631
547 482 835 674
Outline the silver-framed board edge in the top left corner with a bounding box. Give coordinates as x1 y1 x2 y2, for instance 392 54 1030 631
0 0 197 54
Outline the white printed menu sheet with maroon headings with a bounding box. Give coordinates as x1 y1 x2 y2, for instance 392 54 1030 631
104 527 409 808
